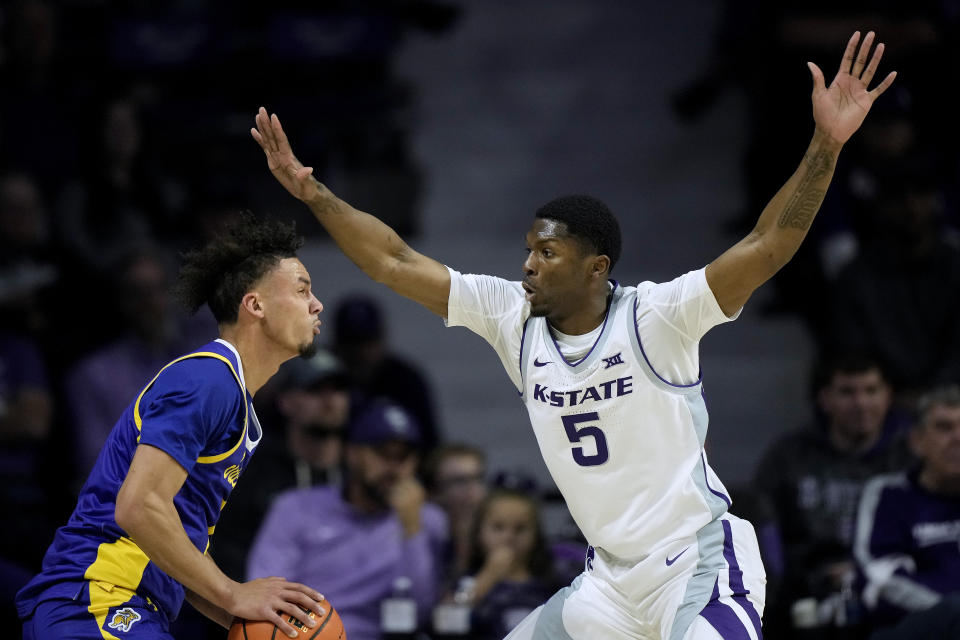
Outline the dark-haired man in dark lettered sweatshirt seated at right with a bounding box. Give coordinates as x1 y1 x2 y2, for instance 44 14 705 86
754 356 909 625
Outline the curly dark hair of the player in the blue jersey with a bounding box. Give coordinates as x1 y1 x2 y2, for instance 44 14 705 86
173 212 303 324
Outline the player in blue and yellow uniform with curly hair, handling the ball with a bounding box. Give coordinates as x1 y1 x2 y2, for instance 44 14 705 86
17 217 323 640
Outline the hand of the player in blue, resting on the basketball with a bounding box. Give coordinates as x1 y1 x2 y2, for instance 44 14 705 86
227 576 326 638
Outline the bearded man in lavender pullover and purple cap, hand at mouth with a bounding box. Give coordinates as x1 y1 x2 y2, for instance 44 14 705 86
247 401 447 640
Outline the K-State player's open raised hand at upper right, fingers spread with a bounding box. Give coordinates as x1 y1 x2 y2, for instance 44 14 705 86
807 31 897 144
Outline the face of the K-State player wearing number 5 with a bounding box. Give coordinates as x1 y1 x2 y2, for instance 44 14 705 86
523 218 595 317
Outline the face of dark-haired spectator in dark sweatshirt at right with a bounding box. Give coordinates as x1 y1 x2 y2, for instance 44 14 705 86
820 369 891 440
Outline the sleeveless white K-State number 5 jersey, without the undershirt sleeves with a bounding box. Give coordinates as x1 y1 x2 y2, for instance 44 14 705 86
520 286 730 558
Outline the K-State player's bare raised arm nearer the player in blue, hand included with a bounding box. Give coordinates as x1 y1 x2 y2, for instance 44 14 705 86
250 107 450 317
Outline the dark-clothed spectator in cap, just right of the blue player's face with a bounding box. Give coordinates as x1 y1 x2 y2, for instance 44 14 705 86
333 295 441 455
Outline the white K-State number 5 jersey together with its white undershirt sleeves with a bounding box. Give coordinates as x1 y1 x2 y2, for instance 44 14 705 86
446 269 739 560
